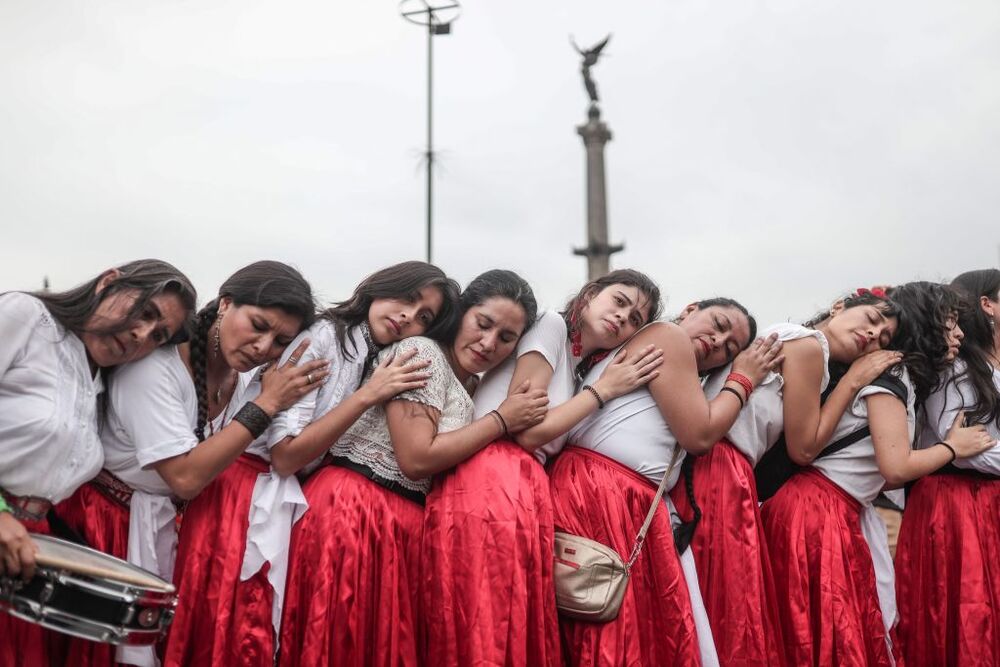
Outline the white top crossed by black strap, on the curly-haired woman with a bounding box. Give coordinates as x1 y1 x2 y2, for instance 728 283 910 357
812 365 916 505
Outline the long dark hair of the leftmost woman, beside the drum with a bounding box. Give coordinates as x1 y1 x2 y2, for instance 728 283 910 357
29 259 198 344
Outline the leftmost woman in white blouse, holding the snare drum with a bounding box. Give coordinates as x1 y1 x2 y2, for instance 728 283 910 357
0 259 196 665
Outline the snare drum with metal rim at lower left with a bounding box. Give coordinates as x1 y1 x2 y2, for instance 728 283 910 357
0 534 177 645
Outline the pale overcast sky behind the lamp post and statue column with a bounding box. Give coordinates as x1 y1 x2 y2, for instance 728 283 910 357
0 0 1000 323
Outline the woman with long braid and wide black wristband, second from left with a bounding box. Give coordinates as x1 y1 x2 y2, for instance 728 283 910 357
59 262 324 664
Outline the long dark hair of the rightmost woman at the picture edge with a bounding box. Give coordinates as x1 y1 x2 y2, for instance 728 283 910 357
950 269 1000 424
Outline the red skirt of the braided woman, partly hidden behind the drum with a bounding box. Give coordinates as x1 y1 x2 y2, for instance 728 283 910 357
56 483 129 667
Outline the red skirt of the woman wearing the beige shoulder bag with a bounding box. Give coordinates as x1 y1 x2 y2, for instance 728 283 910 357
551 447 701 667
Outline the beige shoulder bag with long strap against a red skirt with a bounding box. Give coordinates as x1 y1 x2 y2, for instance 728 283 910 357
553 444 680 623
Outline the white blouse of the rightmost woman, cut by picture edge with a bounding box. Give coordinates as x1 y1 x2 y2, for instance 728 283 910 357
918 359 1000 477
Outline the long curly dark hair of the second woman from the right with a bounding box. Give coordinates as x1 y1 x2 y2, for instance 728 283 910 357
887 281 964 405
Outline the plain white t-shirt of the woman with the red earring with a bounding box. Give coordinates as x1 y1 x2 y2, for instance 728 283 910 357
473 311 574 465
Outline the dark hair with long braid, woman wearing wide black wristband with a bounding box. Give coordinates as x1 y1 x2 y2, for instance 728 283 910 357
191 261 316 440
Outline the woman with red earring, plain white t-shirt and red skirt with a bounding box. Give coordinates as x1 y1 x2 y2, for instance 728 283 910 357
422 270 660 665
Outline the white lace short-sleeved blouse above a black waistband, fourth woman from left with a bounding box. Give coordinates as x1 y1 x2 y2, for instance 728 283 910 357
330 336 473 493
